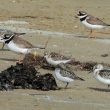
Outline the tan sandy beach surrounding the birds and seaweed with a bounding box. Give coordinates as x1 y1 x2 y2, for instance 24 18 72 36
0 0 110 110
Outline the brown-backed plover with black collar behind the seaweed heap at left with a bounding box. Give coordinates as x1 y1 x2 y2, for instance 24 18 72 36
0 33 45 61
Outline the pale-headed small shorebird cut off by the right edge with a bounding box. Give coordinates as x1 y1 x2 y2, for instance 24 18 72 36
93 64 110 87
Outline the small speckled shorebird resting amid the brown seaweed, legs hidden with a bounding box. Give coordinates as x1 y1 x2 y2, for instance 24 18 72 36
44 53 72 66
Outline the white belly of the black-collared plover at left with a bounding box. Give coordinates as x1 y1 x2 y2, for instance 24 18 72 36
6 41 28 54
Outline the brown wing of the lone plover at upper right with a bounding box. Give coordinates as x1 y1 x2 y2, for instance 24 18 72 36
86 16 108 26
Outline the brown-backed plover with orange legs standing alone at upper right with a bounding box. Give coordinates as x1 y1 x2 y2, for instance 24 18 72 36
78 11 110 37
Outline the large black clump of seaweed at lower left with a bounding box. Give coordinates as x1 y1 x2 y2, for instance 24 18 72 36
0 63 58 91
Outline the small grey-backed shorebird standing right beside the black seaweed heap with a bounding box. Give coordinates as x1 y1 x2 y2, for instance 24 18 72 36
54 63 84 88
